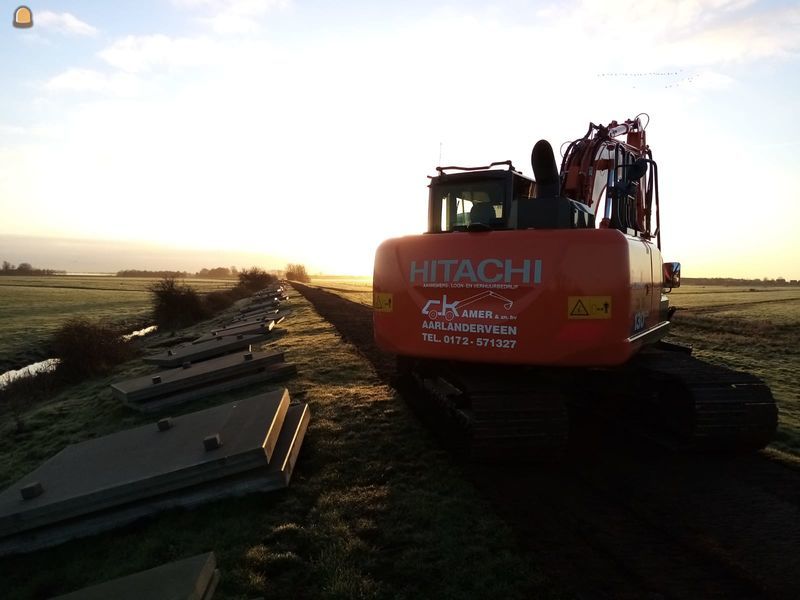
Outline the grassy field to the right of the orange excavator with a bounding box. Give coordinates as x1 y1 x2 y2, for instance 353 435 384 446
670 286 800 455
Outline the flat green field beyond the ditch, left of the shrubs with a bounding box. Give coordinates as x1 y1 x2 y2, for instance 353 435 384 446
0 275 234 372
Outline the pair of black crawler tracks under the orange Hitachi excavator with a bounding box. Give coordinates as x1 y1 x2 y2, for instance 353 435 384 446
409 343 777 460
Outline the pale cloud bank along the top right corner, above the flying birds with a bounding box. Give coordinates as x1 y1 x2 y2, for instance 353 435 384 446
515 0 800 72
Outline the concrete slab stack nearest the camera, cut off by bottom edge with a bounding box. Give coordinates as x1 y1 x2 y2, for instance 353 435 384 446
52 552 219 600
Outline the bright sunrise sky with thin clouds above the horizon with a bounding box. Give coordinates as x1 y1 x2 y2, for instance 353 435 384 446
0 0 800 279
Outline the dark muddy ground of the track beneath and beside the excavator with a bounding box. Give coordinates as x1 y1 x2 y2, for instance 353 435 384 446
296 285 800 600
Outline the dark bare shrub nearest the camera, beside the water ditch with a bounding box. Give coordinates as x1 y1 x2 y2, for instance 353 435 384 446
52 318 135 381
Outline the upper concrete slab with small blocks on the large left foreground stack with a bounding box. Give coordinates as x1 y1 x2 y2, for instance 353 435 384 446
0 389 289 537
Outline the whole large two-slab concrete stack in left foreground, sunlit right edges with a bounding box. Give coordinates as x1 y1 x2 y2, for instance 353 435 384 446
0 390 310 555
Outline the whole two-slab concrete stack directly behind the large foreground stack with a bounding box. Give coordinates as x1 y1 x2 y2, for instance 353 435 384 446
111 352 297 412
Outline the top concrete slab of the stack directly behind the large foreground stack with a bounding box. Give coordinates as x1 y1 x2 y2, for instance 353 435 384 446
111 351 284 403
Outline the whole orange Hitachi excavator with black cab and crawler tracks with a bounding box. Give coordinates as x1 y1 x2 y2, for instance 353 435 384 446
373 115 777 457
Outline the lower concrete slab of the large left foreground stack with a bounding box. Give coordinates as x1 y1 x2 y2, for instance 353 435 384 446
0 404 311 556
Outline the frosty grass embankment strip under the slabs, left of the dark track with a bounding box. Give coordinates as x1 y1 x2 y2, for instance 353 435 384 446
0 294 560 600
